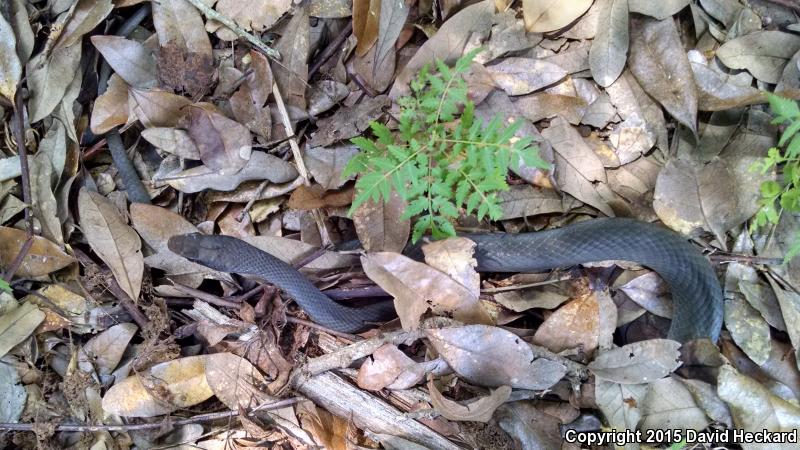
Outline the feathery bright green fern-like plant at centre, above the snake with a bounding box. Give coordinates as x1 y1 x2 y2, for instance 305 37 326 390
342 49 548 242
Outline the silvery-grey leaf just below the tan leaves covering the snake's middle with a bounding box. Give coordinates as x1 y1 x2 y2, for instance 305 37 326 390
425 325 567 390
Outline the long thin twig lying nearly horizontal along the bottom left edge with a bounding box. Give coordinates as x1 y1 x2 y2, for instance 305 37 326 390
0 397 305 432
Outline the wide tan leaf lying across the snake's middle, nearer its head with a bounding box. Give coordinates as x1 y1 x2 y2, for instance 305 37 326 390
361 252 492 330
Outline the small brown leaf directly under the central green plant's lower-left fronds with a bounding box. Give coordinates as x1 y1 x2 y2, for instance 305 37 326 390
353 191 411 253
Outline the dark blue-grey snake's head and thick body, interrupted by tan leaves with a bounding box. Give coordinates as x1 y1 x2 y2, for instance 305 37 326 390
169 218 722 342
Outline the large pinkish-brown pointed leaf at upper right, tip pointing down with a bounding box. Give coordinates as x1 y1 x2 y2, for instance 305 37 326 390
629 16 697 134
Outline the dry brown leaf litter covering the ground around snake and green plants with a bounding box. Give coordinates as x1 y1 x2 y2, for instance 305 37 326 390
0 0 800 448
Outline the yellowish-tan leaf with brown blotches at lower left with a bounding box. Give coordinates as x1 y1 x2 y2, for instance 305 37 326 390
102 355 214 417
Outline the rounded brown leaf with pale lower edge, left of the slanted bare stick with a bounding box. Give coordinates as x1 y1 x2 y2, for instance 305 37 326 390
179 103 252 175
